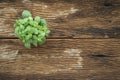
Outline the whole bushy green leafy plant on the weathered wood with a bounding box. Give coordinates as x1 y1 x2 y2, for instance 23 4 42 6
14 10 50 48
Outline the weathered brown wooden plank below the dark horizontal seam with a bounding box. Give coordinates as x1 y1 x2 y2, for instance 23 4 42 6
0 39 120 80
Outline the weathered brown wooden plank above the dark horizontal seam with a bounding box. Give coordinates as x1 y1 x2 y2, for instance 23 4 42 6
0 0 120 38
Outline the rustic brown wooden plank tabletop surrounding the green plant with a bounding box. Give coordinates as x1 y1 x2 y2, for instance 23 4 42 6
0 0 120 80
